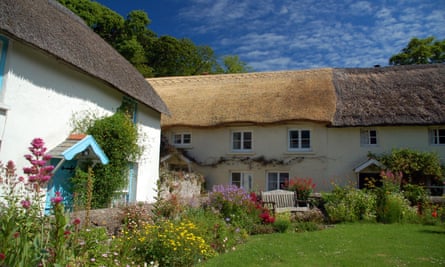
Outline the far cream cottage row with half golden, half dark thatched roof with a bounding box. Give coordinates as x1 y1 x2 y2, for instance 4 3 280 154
148 64 445 195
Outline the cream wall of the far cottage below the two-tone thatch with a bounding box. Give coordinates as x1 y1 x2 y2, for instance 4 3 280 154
163 122 445 192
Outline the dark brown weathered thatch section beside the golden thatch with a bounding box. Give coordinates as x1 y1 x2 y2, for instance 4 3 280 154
332 64 445 127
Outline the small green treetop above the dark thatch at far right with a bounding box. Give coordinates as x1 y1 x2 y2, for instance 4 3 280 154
389 36 445 65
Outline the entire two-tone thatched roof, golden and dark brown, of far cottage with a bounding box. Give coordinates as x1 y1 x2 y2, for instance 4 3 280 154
148 64 445 129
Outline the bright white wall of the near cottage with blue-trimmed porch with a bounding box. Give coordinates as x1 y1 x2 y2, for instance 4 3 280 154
0 38 160 201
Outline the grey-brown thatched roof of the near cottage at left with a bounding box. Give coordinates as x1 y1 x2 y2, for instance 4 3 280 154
0 0 168 113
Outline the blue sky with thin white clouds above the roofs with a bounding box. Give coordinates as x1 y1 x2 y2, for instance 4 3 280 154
95 0 445 71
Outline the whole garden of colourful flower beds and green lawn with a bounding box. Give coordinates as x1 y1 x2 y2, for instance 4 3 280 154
0 138 445 266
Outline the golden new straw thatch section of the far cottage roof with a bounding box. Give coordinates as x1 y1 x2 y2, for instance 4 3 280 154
147 69 336 128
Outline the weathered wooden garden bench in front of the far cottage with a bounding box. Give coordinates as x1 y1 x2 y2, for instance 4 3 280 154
260 189 309 215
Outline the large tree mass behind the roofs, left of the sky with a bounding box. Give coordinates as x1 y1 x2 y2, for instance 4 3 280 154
58 0 252 77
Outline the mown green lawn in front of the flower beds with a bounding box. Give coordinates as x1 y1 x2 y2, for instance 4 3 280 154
200 223 445 267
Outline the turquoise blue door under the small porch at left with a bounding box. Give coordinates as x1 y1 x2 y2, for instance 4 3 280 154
45 159 77 214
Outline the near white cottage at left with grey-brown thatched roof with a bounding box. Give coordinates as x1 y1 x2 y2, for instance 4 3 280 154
0 0 168 204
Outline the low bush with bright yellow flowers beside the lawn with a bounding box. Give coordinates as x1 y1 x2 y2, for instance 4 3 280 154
125 220 216 266
